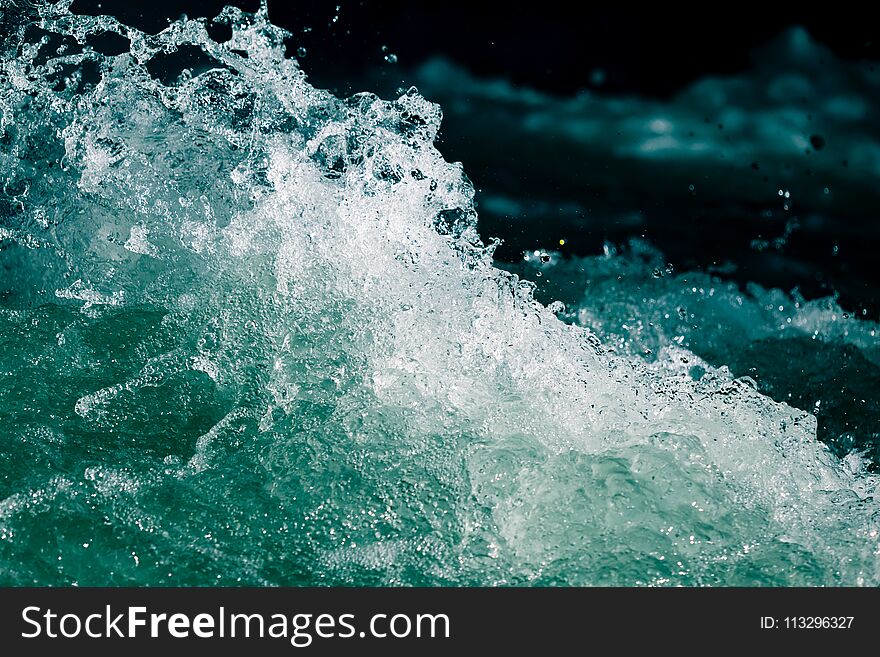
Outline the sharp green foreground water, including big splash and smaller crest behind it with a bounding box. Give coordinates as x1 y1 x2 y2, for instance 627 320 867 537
0 0 880 585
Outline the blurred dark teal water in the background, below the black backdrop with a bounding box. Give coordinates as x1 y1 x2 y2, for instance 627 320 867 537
410 31 880 320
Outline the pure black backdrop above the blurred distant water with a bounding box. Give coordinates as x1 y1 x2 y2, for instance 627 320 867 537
73 0 880 97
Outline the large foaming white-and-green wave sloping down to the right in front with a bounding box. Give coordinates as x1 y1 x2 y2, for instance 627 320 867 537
0 0 880 584
